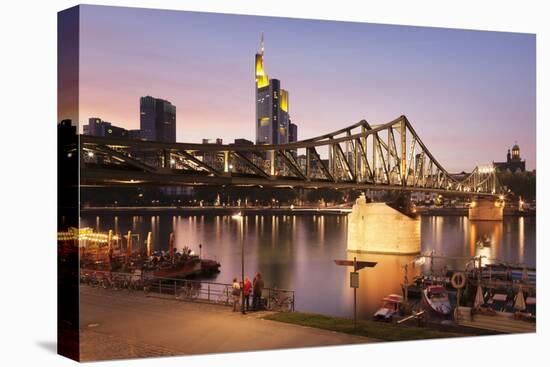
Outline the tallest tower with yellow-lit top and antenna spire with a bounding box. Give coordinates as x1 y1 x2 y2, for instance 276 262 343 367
255 33 290 144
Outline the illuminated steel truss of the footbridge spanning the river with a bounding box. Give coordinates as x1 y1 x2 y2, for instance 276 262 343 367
79 116 501 196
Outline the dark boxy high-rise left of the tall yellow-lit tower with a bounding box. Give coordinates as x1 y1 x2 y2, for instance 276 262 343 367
139 96 176 143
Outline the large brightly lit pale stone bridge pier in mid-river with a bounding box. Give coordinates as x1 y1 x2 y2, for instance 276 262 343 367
348 195 420 255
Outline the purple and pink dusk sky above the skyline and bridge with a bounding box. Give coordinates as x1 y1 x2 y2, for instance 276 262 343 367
72 6 536 172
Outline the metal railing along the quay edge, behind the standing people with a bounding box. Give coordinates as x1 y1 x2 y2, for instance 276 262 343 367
80 269 295 312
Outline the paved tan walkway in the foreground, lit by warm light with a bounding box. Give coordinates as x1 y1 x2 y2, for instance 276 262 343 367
80 286 375 361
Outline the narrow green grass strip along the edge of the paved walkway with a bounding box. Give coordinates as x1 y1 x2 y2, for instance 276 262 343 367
263 312 475 341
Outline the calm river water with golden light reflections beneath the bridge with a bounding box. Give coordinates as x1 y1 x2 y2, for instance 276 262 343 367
81 214 536 318
